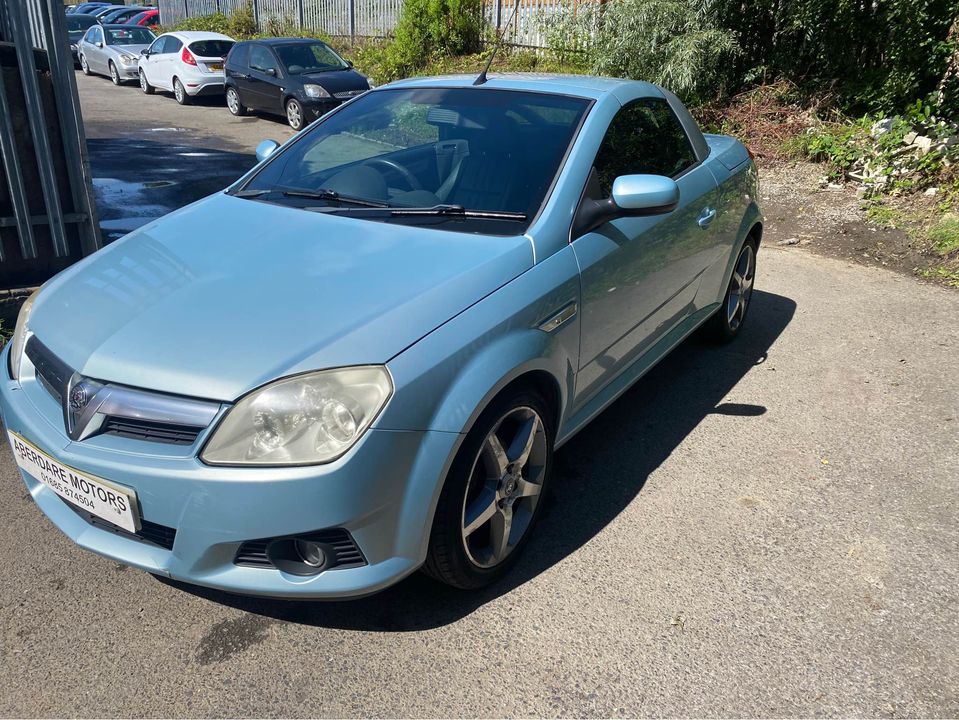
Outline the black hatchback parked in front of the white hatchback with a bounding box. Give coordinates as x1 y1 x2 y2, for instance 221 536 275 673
226 38 372 130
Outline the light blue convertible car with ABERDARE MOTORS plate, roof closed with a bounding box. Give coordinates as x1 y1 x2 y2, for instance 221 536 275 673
0 75 762 598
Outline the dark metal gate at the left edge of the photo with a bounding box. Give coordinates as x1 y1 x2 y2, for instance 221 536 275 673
0 0 101 289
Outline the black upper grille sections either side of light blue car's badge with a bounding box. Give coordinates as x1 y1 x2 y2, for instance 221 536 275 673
25 335 218 445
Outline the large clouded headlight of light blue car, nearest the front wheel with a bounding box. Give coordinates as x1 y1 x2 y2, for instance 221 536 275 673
200 365 393 465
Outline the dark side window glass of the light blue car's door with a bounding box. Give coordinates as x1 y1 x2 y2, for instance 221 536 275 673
594 98 696 197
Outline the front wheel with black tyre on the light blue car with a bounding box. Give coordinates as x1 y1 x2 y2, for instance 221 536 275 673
423 389 555 590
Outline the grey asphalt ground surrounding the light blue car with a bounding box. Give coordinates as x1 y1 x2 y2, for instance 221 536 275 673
0 70 959 717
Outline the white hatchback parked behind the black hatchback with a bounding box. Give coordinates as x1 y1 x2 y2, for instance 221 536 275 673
137 32 236 105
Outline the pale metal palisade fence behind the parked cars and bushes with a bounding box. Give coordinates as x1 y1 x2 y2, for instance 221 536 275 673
159 0 565 47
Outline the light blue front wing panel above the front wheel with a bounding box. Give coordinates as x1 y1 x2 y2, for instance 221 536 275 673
375 246 579 558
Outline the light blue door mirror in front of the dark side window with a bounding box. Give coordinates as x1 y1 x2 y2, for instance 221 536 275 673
573 175 679 239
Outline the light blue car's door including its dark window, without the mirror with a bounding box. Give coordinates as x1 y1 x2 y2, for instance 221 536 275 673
573 97 716 402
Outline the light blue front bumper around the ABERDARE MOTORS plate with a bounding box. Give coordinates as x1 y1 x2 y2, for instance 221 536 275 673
0 350 459 598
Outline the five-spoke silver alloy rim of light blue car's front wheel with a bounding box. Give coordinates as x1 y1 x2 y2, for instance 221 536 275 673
461 407 548 568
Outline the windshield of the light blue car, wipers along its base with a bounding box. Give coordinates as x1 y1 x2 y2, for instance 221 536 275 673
238 87 590 234
